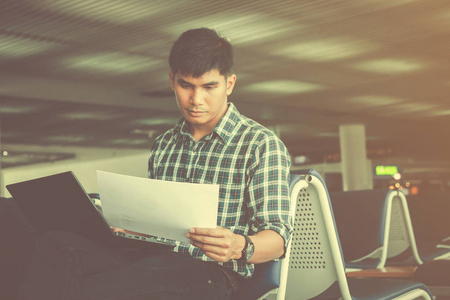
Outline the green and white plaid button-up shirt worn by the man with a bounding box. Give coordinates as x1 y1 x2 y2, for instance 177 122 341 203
148 103 292 277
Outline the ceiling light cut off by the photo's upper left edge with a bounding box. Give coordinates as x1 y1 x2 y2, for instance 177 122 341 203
0 34 55 57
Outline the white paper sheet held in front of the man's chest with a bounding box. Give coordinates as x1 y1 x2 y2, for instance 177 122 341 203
97 171 219 242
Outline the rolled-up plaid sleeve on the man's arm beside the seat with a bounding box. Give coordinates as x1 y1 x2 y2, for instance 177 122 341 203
248 136 292 253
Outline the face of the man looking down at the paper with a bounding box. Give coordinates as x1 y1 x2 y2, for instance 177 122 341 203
169 69 236 132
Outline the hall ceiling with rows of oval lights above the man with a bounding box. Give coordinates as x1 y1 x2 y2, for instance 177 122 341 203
0 0 450 178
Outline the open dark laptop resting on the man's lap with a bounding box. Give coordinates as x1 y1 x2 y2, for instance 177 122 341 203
6 171 175 249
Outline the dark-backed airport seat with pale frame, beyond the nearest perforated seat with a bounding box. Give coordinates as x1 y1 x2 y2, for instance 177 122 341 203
330 189 422 270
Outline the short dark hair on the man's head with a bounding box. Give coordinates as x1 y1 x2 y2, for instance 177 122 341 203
169 28 233 77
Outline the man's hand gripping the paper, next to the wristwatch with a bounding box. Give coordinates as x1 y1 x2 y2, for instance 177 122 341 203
186 226 245 262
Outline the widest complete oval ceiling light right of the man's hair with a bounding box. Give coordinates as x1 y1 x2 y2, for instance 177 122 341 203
273 38 375 62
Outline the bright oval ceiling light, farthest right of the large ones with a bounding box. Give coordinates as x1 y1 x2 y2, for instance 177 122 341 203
354 59 424 74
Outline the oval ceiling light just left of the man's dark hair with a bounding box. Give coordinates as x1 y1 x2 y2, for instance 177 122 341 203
62 52 160 73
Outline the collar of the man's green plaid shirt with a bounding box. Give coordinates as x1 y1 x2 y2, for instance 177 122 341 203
173 102 240 144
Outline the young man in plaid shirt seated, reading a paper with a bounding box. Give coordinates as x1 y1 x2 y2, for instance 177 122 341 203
25 28 292 300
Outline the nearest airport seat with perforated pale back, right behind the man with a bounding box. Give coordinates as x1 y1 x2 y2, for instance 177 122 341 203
286 170 432 300
